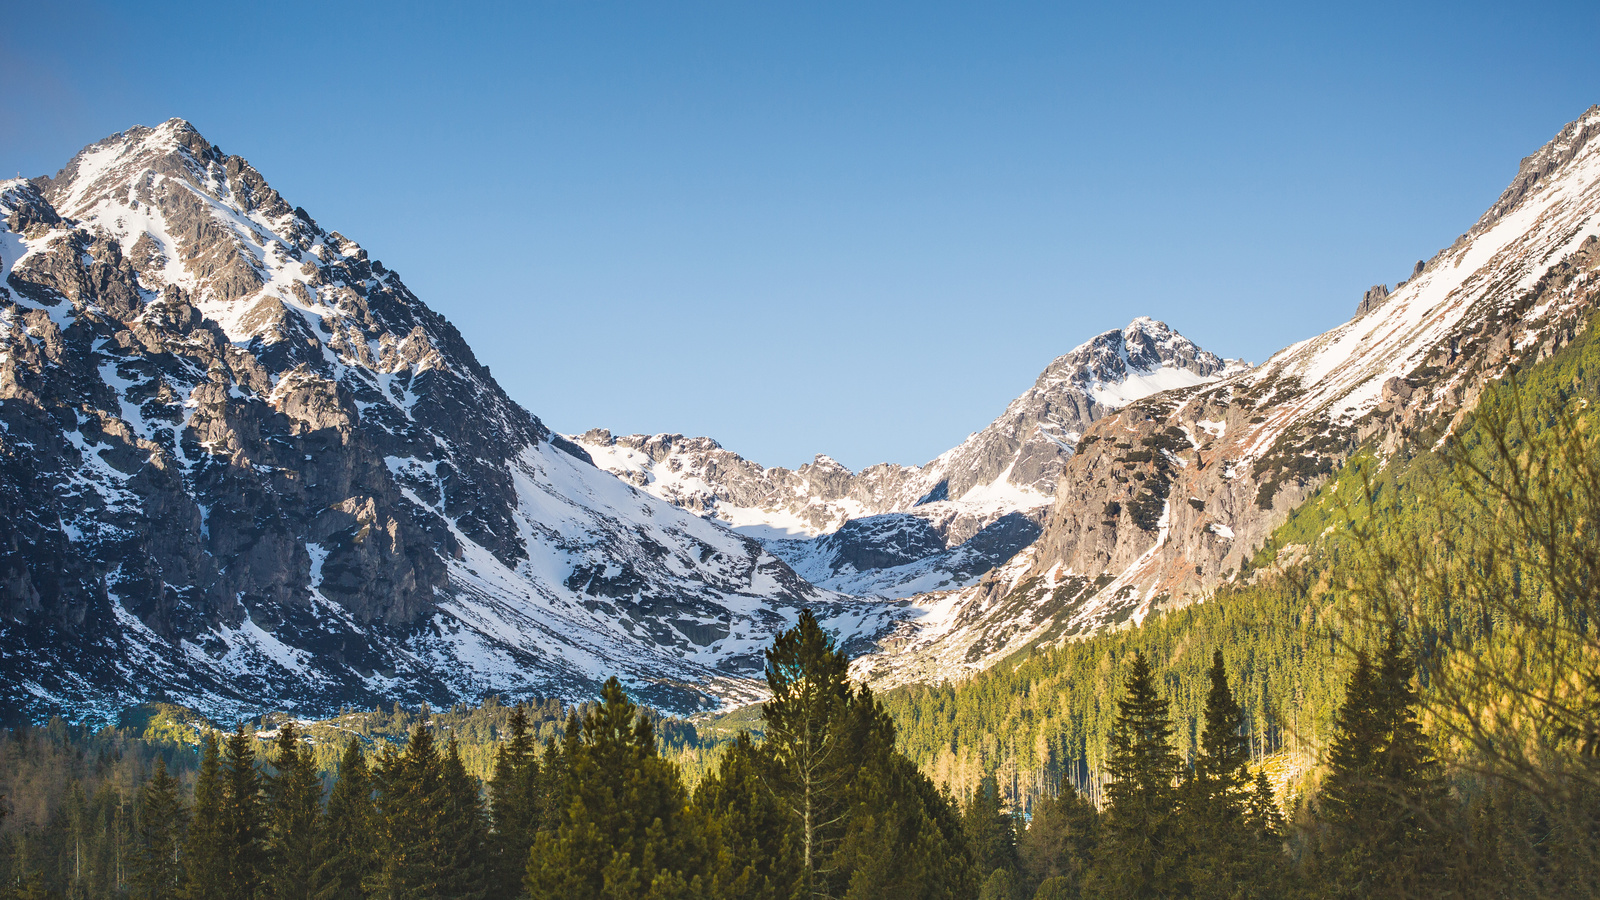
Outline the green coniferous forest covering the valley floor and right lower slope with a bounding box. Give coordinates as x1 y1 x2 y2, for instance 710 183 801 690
0 323 1600 900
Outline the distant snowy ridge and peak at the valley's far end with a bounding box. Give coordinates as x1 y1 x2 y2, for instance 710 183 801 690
573 319 1229 599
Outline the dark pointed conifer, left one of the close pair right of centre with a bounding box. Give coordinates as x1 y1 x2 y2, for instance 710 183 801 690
1090 653 1186 898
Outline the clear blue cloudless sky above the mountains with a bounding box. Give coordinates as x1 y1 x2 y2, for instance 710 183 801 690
0 0 1600 468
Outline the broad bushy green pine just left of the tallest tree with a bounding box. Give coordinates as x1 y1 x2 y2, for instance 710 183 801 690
526 677 712 900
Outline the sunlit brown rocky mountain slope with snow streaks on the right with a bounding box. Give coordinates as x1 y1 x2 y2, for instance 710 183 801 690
858 107 1600 684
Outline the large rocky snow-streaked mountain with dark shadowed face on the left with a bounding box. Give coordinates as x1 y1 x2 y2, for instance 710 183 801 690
0 120 896 721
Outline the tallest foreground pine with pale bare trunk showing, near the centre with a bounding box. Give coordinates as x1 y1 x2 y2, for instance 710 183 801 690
762 610 862 897
